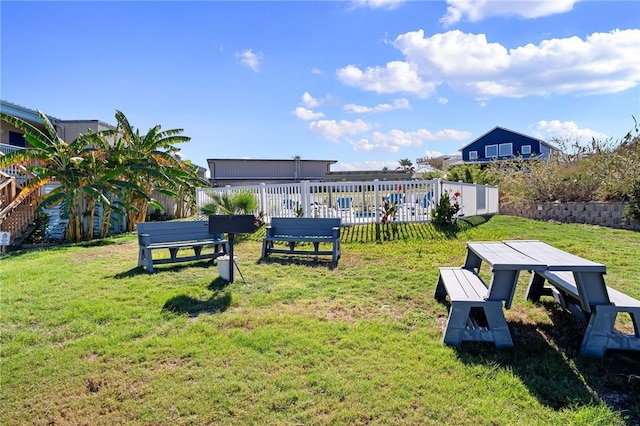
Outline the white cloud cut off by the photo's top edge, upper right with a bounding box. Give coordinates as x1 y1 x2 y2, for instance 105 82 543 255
440 0 580 27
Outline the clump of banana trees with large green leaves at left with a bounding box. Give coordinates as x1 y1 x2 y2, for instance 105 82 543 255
0 111 208 241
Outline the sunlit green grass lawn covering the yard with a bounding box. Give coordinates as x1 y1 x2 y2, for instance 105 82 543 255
0 216 640 425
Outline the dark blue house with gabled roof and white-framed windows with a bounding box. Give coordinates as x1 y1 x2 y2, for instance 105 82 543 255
460 127 558 164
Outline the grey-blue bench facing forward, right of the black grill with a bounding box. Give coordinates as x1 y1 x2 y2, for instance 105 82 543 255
262 217 341 263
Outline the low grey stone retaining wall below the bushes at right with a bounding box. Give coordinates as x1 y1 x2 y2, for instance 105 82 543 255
500 202 640 231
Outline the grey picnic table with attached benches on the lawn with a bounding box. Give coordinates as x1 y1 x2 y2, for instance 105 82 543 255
435 240 640 356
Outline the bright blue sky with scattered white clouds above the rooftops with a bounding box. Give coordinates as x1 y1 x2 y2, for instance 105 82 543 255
0 0 640 170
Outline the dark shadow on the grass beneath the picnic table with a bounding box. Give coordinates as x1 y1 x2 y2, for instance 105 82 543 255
456 303 640 424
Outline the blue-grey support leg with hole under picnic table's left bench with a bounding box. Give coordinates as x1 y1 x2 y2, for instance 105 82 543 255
442 301 513 347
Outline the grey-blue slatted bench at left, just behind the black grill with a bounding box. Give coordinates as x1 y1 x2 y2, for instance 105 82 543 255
137 221 228 273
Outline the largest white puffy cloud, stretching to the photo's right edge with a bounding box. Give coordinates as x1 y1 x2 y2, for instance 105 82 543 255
337 29 640 100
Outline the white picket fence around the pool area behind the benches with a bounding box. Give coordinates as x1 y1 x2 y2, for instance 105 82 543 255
196 180 499 225
